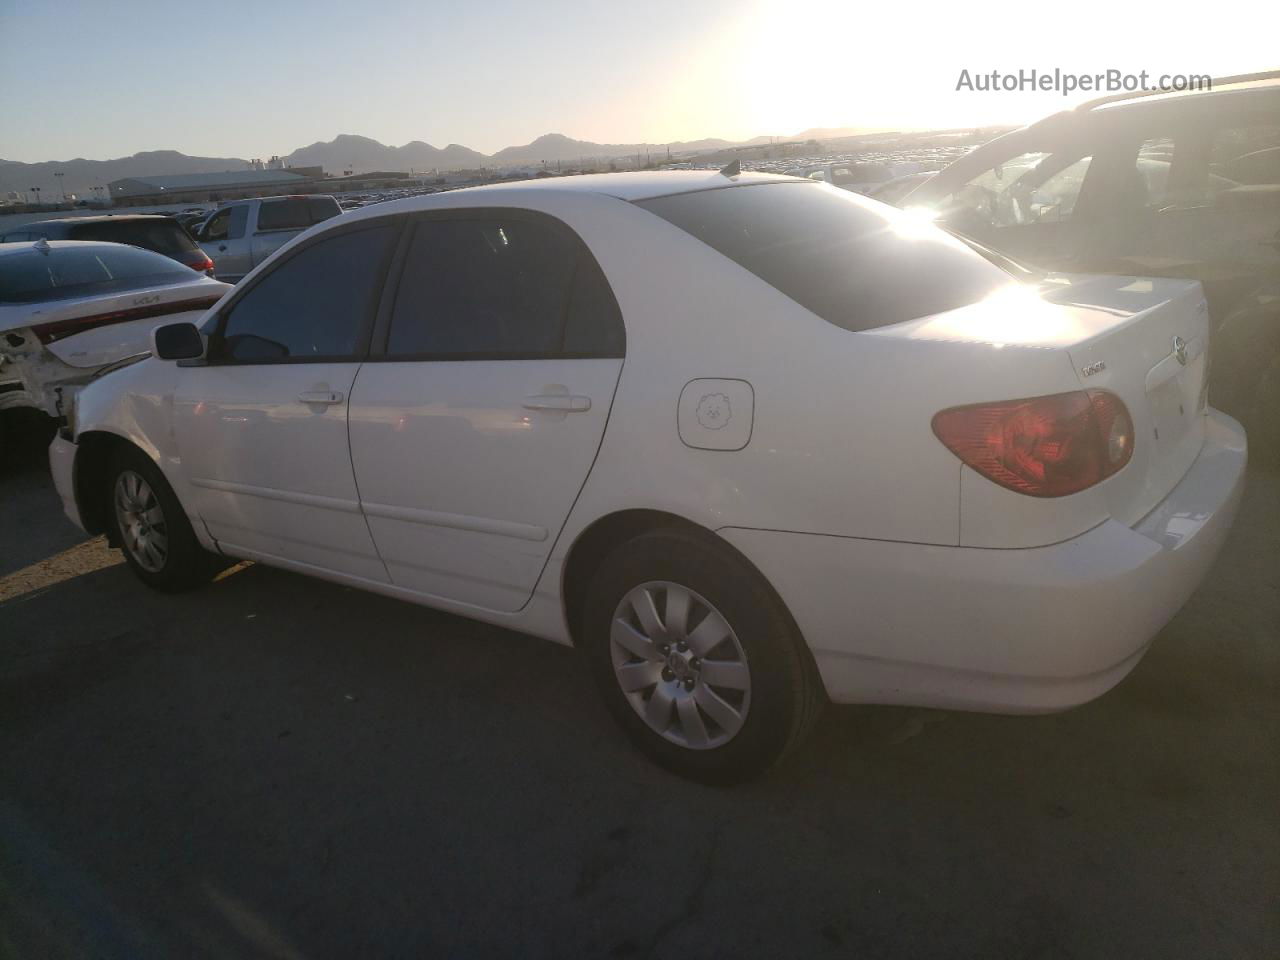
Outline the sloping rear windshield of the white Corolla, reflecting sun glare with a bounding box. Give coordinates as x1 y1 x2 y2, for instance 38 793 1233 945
637 182 1014 330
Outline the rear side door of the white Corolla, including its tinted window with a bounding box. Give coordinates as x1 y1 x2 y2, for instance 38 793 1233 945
351 211 626 611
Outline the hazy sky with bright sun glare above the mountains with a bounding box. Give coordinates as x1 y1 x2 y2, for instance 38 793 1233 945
0 0 1280 161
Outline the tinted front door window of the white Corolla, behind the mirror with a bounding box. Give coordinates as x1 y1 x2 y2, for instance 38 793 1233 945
211 225 397 364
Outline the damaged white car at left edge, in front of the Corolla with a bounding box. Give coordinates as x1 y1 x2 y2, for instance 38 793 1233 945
0 241 232 435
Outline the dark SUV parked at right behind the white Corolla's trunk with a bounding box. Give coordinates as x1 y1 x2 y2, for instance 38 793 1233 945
902 72 1280 458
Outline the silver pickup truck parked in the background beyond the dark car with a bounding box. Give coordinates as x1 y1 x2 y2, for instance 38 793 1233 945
195 196 342 283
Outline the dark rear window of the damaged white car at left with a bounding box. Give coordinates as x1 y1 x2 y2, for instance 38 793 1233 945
0 243 193 303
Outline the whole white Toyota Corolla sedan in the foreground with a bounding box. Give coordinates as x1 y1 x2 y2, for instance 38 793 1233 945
50 172 1245 782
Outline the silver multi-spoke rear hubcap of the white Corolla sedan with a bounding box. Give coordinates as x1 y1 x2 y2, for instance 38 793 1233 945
609 580 751 750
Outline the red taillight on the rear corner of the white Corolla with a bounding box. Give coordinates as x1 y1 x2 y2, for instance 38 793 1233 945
933 390 1134 497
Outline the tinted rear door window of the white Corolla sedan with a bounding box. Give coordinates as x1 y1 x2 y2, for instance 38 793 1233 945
387 216 626 360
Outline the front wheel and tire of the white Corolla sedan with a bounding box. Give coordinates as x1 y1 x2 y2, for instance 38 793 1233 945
104 447 219 593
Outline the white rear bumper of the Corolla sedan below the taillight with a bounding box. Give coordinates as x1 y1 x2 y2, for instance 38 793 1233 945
722 410 1248 713
